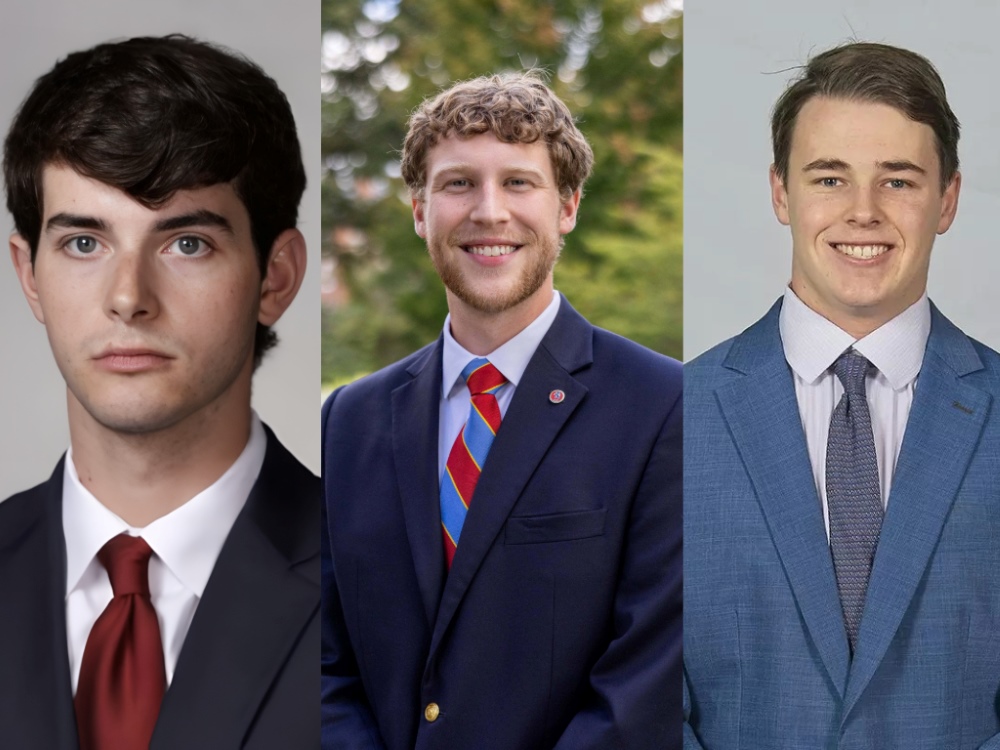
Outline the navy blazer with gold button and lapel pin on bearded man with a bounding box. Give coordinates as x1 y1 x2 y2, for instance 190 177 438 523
322 300 682 750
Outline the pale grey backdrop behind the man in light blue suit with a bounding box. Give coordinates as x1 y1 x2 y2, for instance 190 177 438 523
684 0 1000 359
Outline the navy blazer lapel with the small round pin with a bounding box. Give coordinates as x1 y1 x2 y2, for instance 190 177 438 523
430 299 593 657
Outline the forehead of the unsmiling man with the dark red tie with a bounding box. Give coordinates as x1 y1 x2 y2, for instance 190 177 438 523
42 164 250 231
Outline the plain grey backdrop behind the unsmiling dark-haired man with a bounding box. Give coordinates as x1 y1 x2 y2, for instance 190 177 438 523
0 0 320 500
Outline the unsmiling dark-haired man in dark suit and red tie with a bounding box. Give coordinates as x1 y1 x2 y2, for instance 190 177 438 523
0 36 320 750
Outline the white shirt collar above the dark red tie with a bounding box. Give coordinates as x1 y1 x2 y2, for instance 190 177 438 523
62 413 267 598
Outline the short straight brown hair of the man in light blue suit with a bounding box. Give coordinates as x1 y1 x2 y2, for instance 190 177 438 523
771 42 960 190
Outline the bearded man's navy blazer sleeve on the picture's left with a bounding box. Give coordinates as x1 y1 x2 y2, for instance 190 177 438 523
321 393 385 750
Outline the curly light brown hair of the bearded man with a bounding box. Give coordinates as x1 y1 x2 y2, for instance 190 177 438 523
401 70 594 201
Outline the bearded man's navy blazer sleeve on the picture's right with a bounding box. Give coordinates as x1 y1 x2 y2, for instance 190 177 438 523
555 394 682 750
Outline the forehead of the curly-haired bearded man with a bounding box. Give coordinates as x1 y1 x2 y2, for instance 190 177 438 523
426 133 553 181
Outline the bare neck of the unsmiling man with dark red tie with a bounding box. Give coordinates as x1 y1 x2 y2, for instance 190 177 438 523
68 390 250 528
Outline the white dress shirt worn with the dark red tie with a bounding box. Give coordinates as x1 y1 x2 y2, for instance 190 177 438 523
62 414 267 695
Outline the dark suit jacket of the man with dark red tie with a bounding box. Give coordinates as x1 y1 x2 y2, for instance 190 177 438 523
0 430 320 750
